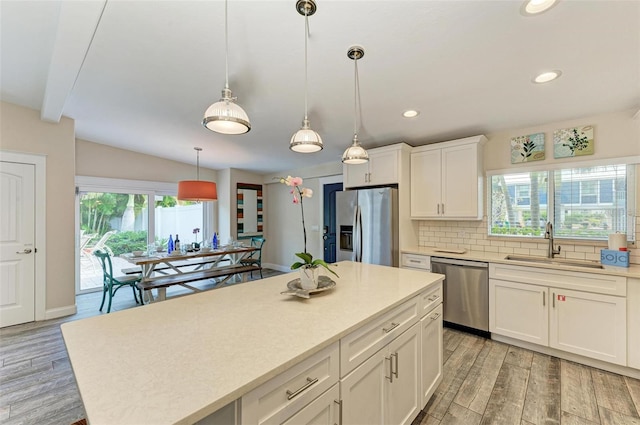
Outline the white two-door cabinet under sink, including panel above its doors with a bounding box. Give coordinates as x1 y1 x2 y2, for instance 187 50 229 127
489 264 627 366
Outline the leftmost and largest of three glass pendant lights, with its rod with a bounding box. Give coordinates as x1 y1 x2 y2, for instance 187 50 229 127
202 0 251 134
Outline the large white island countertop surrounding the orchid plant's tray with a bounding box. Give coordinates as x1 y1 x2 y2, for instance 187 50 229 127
61 262 443 425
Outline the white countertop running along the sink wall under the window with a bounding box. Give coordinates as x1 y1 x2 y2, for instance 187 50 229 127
401 246 640 278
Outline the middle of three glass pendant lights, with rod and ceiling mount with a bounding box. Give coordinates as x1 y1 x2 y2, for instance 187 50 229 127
289 0 323 153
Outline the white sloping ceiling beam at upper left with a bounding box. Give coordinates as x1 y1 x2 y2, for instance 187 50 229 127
40 0 107 122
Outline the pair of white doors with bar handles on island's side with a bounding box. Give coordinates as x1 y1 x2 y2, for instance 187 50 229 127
340 323 422 425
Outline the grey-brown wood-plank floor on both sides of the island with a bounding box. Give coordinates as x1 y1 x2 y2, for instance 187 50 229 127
0 271 640 425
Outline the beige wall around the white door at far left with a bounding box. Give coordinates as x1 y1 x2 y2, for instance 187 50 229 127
0 102 75 311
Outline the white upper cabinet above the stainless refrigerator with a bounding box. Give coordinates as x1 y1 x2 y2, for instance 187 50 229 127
342 143 411 189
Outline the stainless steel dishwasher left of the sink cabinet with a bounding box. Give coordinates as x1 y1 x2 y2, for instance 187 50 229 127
431 257 490 337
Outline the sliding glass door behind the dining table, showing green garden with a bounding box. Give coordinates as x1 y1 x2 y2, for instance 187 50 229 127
76 177 210 293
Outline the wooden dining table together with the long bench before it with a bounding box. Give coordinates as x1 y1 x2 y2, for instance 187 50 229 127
123 246 257 302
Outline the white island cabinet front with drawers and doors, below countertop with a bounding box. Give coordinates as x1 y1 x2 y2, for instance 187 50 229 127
240 281 443 425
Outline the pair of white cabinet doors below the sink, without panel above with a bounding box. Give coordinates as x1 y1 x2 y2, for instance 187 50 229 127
489 279 627 366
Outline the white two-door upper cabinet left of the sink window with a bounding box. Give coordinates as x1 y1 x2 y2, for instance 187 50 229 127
411 136 487 220
